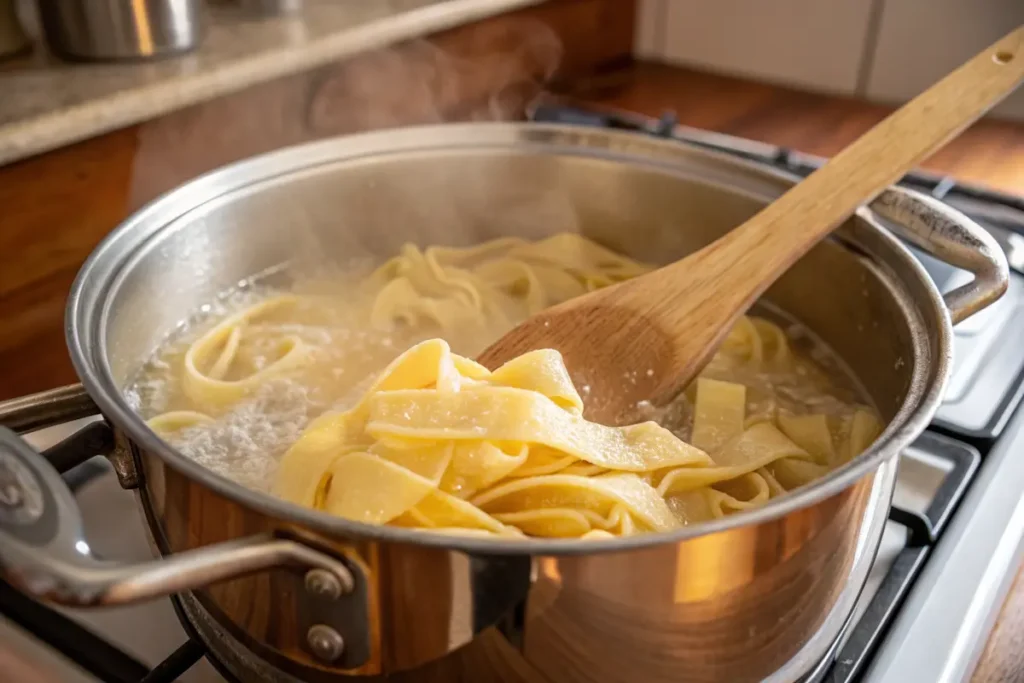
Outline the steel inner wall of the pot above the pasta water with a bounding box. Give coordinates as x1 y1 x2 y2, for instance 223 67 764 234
81 125 945 483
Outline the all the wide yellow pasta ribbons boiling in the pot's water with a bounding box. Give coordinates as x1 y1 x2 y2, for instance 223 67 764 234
135 234 881 539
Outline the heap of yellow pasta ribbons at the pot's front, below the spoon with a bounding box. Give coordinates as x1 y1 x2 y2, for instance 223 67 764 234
274 339 877 539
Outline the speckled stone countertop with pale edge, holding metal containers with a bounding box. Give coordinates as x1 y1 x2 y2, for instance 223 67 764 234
0 0 541 165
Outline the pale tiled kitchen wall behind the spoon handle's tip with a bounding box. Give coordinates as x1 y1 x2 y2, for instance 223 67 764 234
636 0 1024 121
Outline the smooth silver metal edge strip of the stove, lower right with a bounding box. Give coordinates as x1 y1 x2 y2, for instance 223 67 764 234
866 397 1024 683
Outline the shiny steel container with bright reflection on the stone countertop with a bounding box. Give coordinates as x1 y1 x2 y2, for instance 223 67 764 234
39 0 203 60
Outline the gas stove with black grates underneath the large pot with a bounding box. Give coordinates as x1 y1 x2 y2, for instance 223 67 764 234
0 103 1024 683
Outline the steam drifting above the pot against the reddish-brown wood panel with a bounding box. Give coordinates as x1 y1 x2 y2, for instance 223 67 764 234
126 19 562 205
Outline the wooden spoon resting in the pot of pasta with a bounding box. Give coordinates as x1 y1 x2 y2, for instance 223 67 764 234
480 26 1024 424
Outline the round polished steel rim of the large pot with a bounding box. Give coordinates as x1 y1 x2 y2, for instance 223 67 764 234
65 123 952 555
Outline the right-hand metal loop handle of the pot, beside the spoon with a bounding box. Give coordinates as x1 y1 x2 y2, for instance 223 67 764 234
869 187 1010 325
